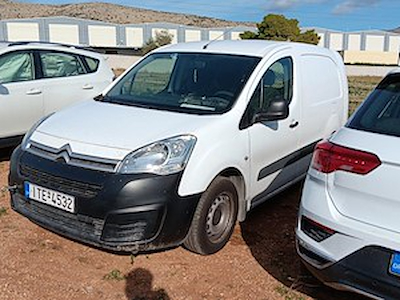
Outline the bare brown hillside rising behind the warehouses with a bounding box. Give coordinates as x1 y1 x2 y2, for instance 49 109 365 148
0 0 254 27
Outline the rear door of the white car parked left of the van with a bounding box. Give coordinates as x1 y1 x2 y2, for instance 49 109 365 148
37 50 104 114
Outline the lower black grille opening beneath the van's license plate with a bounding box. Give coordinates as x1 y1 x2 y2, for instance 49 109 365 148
15 198 104 240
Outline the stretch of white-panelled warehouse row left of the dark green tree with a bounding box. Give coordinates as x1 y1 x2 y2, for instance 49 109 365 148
0 17 254 48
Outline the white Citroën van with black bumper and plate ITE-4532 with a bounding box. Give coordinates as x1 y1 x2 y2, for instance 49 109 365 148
10 41 348 254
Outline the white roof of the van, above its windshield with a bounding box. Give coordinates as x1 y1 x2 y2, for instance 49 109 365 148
155 40 326 57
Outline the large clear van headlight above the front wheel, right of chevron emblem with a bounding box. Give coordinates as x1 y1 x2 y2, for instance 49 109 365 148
118 135 196 175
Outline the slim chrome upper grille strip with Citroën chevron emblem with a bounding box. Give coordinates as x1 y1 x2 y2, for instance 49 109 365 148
27 142 119 172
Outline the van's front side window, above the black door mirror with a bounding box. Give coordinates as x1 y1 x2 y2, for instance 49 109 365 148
242 57 293 123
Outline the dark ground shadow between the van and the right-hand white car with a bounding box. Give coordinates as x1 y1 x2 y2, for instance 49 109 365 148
241 184 365 300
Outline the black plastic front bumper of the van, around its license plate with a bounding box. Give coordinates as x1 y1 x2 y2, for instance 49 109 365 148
9 148 201 252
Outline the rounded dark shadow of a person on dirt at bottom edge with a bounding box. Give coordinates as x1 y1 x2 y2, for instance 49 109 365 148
125 268 171 300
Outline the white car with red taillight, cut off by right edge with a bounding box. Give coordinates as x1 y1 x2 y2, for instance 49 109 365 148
296 70 400 299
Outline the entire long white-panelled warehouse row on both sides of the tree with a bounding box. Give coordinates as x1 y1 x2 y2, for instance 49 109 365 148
0 17 400 65
